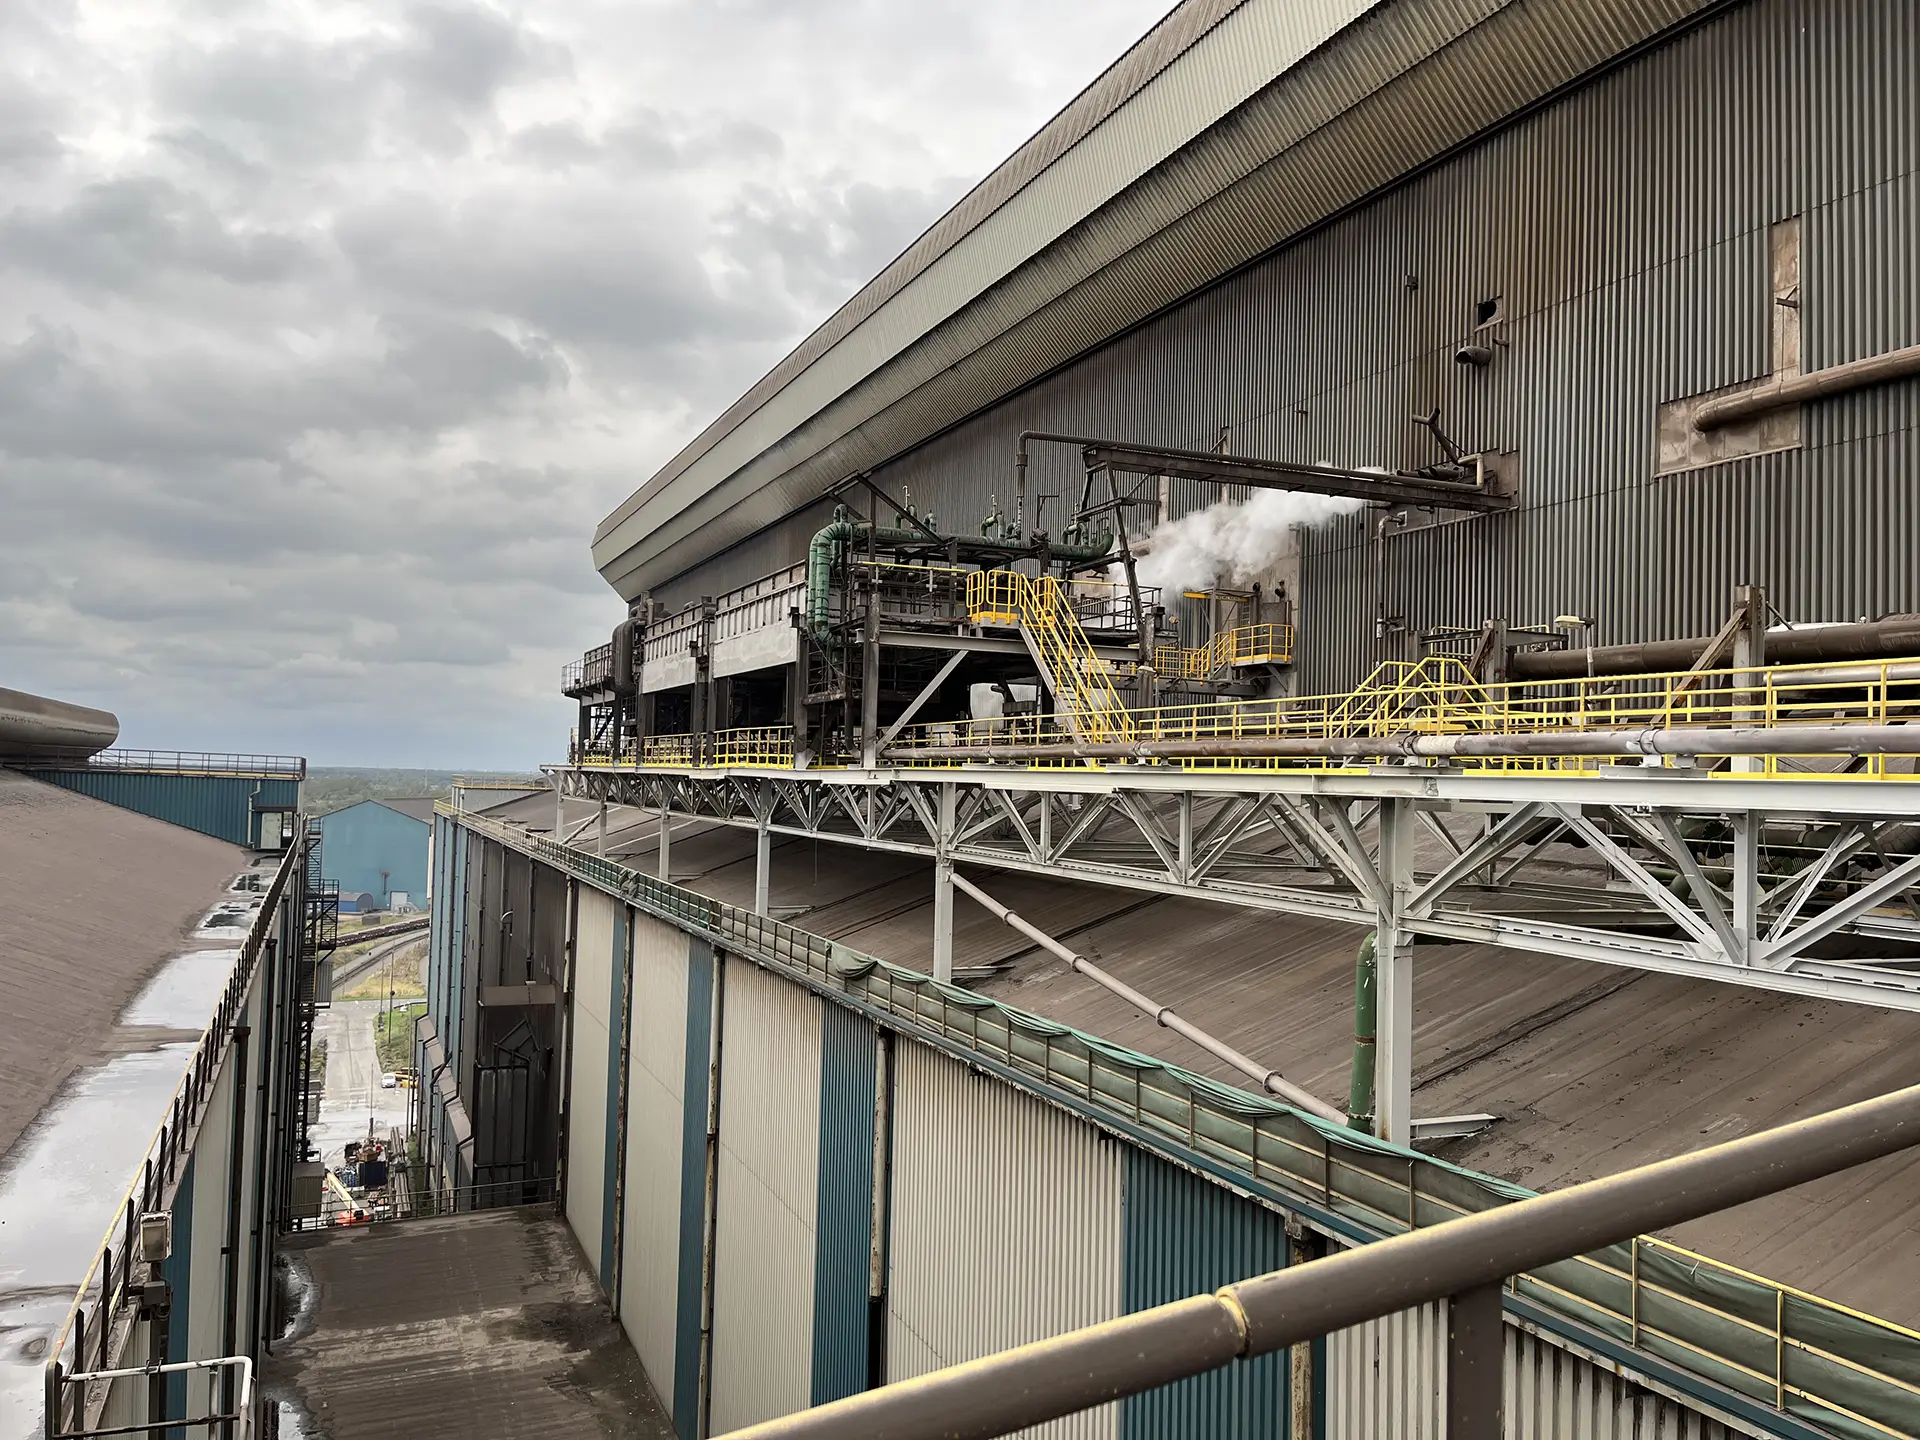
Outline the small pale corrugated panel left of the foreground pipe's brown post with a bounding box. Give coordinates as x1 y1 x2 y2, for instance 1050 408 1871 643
1327 1302 1446 1440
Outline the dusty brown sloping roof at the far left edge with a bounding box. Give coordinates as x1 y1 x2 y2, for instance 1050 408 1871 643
0 770 248 1156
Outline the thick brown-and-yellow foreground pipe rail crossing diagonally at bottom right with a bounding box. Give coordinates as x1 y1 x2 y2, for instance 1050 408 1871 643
732 1087 1920 1440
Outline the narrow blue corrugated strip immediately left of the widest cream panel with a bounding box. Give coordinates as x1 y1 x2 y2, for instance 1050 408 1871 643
814 1004 879 1405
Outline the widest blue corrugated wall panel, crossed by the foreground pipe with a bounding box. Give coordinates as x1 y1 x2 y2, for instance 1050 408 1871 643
1119 1146 1286 1440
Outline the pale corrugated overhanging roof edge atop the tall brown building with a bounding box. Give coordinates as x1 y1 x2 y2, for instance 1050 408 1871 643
593 0 1715 597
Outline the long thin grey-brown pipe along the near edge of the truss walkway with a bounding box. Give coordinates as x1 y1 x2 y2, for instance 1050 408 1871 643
887 724 1920 760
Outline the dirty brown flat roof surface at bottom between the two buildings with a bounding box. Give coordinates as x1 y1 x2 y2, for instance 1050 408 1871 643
263 1206 674 1440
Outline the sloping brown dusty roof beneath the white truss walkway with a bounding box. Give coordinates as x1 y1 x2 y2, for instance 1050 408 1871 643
514 801 1920 1325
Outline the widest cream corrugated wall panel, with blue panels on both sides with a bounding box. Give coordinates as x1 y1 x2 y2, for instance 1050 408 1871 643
887 1039 1121 1440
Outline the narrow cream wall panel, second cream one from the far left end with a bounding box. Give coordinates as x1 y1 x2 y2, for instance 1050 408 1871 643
620 914 687 1409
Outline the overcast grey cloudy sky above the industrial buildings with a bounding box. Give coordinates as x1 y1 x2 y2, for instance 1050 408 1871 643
0 0 1167 768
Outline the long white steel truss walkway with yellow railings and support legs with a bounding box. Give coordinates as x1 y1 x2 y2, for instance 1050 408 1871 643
549 662 1920 1142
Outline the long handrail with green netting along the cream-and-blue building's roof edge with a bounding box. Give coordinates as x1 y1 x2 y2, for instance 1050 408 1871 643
456 806 1920 1440
